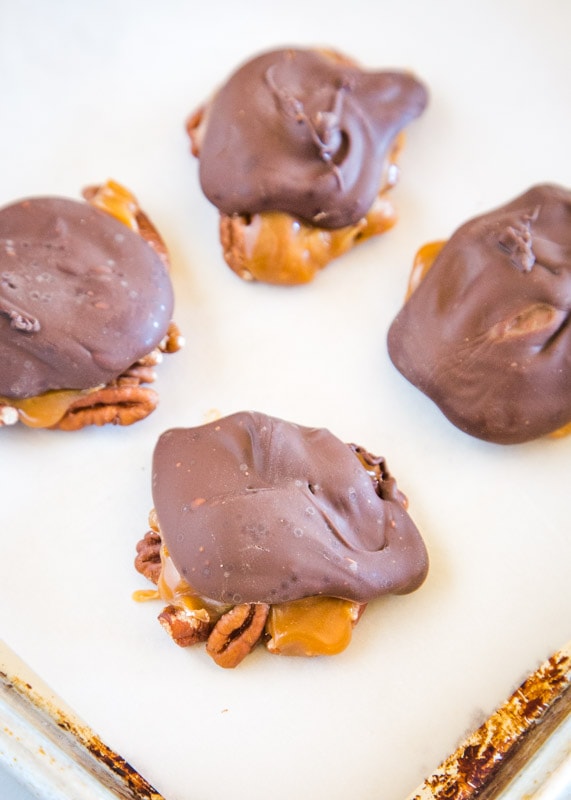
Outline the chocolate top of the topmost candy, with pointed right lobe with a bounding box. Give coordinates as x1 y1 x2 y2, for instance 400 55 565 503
194 50 427 228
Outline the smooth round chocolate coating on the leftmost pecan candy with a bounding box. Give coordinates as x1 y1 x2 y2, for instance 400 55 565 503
0 197 173 398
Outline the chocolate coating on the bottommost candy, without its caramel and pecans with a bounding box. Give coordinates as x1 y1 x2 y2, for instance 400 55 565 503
153 412 428 604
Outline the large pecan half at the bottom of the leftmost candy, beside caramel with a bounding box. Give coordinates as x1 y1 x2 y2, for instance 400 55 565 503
53 384 159 431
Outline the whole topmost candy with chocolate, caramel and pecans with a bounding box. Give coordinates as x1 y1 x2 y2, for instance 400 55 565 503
186 48 428 286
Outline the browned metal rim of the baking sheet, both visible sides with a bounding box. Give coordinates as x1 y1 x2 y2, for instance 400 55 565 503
0 640 571 800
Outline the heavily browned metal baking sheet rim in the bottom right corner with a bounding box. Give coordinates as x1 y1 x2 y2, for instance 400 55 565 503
407 642 571 800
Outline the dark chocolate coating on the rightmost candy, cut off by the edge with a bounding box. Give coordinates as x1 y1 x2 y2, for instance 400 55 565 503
388 185 571 444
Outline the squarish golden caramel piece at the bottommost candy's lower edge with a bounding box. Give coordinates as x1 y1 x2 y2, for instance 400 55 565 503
266 597 359 656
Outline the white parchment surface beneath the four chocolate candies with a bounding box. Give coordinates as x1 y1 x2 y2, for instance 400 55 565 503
0 0 571 800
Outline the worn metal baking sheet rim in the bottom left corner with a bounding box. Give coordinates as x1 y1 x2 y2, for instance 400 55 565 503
0 640 164 800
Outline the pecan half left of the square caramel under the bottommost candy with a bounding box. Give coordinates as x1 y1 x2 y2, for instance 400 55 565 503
206 603 270 669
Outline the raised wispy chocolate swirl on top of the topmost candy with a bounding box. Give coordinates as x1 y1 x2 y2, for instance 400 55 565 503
265 64 351 191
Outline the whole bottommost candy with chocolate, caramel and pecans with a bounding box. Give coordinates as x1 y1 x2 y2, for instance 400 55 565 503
139 411 428 667
